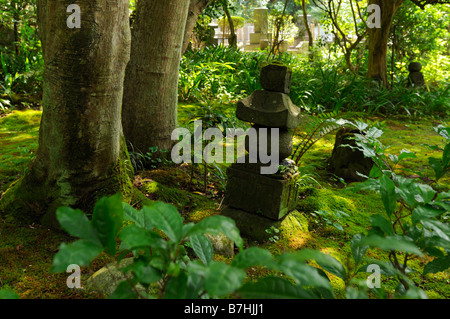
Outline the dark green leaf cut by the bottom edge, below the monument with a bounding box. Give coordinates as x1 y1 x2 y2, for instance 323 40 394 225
238 277 317 299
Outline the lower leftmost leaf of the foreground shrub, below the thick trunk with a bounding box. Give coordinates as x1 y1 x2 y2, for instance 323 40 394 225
50 239 103 273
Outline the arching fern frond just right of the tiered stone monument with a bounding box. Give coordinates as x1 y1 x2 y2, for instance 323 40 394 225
292 111 342 166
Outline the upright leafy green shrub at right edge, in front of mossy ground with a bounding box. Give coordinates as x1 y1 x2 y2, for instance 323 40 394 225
340 122 450 295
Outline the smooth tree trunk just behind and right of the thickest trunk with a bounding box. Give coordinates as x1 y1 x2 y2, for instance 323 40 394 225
122 0 189 152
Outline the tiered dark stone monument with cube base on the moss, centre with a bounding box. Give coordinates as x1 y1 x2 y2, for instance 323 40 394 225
222 64 300 241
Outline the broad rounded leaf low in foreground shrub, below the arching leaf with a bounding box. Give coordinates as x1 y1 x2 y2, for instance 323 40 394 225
205 261 247 297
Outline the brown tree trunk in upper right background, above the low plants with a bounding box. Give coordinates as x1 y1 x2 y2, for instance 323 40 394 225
367 0 404 87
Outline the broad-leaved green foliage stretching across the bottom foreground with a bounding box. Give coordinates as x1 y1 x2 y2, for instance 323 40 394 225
52 182 449 299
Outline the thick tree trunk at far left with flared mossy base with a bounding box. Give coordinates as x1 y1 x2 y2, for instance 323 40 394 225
0 0 131 226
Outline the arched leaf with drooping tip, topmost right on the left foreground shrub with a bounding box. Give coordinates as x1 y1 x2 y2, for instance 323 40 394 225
186 215 244 250
